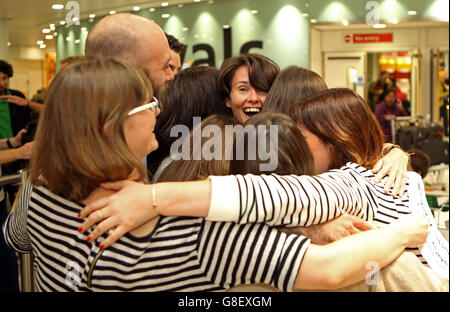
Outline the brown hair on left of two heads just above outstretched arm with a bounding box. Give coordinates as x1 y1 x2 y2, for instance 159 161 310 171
158 115 238 182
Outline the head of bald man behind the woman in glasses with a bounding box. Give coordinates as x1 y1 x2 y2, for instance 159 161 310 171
85 13 174 98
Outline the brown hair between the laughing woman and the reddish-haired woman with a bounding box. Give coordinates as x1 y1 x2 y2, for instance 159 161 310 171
263 66 328 114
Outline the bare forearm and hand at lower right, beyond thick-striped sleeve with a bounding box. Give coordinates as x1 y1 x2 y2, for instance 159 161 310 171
294 215 428 289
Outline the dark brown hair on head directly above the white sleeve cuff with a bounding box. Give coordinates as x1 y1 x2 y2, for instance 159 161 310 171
230 112 314 175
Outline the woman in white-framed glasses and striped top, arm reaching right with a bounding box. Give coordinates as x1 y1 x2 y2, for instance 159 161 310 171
4 60 427 291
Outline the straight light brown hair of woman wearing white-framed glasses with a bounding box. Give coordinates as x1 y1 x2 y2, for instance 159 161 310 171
30 59 153 201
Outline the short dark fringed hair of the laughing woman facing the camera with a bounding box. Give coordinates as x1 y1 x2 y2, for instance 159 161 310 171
219 53 280 99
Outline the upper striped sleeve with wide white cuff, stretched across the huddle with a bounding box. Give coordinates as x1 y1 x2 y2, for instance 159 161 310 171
207 170 377 226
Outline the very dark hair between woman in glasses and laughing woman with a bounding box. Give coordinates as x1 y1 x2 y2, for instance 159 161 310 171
147 66 231 174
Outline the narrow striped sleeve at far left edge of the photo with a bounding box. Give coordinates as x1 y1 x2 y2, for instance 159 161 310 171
3 182 33 253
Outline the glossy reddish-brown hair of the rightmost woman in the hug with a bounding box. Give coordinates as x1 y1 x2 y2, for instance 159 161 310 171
290 88 384 169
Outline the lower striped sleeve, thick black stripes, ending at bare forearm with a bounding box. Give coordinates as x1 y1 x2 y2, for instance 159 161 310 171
199 222 310 291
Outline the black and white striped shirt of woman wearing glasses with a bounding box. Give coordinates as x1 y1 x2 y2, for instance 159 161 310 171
4 179 309 291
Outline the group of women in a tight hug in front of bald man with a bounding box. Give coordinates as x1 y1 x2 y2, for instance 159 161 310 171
3 14 448 291
